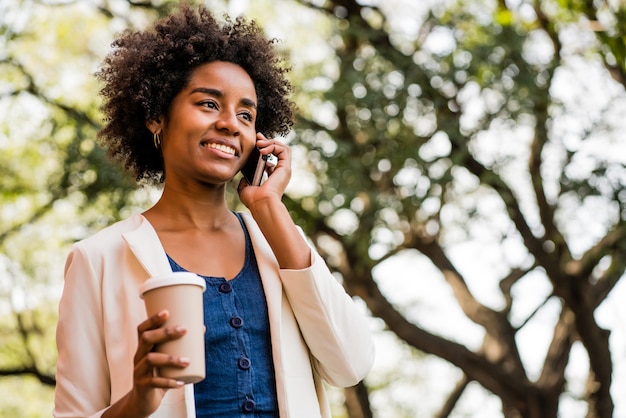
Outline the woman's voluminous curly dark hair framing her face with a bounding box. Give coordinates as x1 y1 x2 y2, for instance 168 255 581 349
96 4 294 184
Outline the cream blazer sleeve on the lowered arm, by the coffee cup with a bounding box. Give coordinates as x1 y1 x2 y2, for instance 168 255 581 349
53 244 111 418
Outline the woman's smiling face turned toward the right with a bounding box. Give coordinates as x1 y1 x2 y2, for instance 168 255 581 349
149 61 257 185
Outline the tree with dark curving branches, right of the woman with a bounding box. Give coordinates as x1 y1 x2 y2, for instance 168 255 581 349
284 0 626 418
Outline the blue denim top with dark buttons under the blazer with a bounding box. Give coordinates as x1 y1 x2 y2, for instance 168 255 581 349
168 213 278 418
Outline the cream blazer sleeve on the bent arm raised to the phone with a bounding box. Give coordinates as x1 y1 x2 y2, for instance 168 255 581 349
280 248 374 387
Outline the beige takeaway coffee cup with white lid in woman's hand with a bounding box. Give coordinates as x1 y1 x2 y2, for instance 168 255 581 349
139 272 206 383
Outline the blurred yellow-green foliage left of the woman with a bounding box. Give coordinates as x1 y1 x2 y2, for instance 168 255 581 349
0 0 161 417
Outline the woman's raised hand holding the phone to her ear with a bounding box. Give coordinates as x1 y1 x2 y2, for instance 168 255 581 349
237 133 291 209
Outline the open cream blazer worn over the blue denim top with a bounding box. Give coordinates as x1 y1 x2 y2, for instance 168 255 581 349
53 214 374 418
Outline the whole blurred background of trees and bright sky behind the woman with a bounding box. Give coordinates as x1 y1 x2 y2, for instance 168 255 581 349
0 0 626 418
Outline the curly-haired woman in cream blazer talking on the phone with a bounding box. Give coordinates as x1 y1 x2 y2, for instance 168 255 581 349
54 6 373 418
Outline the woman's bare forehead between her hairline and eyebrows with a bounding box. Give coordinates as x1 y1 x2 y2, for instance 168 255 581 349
187 61 256 101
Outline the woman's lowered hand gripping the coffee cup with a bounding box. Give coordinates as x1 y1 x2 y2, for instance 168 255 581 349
102 310 189 418
